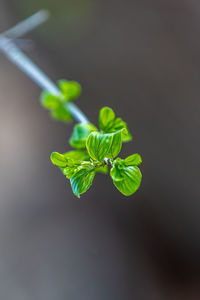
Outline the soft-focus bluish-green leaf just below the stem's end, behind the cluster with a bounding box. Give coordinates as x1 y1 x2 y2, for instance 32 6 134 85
69 123 97 149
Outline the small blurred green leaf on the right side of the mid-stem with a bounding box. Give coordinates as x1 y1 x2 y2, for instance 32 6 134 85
58 79 81 101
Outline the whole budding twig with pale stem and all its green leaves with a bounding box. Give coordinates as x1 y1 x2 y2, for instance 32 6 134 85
0 11 142 197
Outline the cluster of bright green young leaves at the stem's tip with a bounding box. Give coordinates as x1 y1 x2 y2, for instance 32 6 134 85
49 104 142 197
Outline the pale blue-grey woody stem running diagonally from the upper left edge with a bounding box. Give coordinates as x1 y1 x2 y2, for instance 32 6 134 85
0 11 89 123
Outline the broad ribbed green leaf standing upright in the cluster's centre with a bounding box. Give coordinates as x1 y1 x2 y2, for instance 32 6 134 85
86 131 122 161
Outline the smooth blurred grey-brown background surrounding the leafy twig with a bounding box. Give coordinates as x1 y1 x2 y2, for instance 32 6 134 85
0 0 200 300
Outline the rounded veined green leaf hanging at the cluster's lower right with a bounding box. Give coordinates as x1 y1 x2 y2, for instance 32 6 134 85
110 158 142 196
